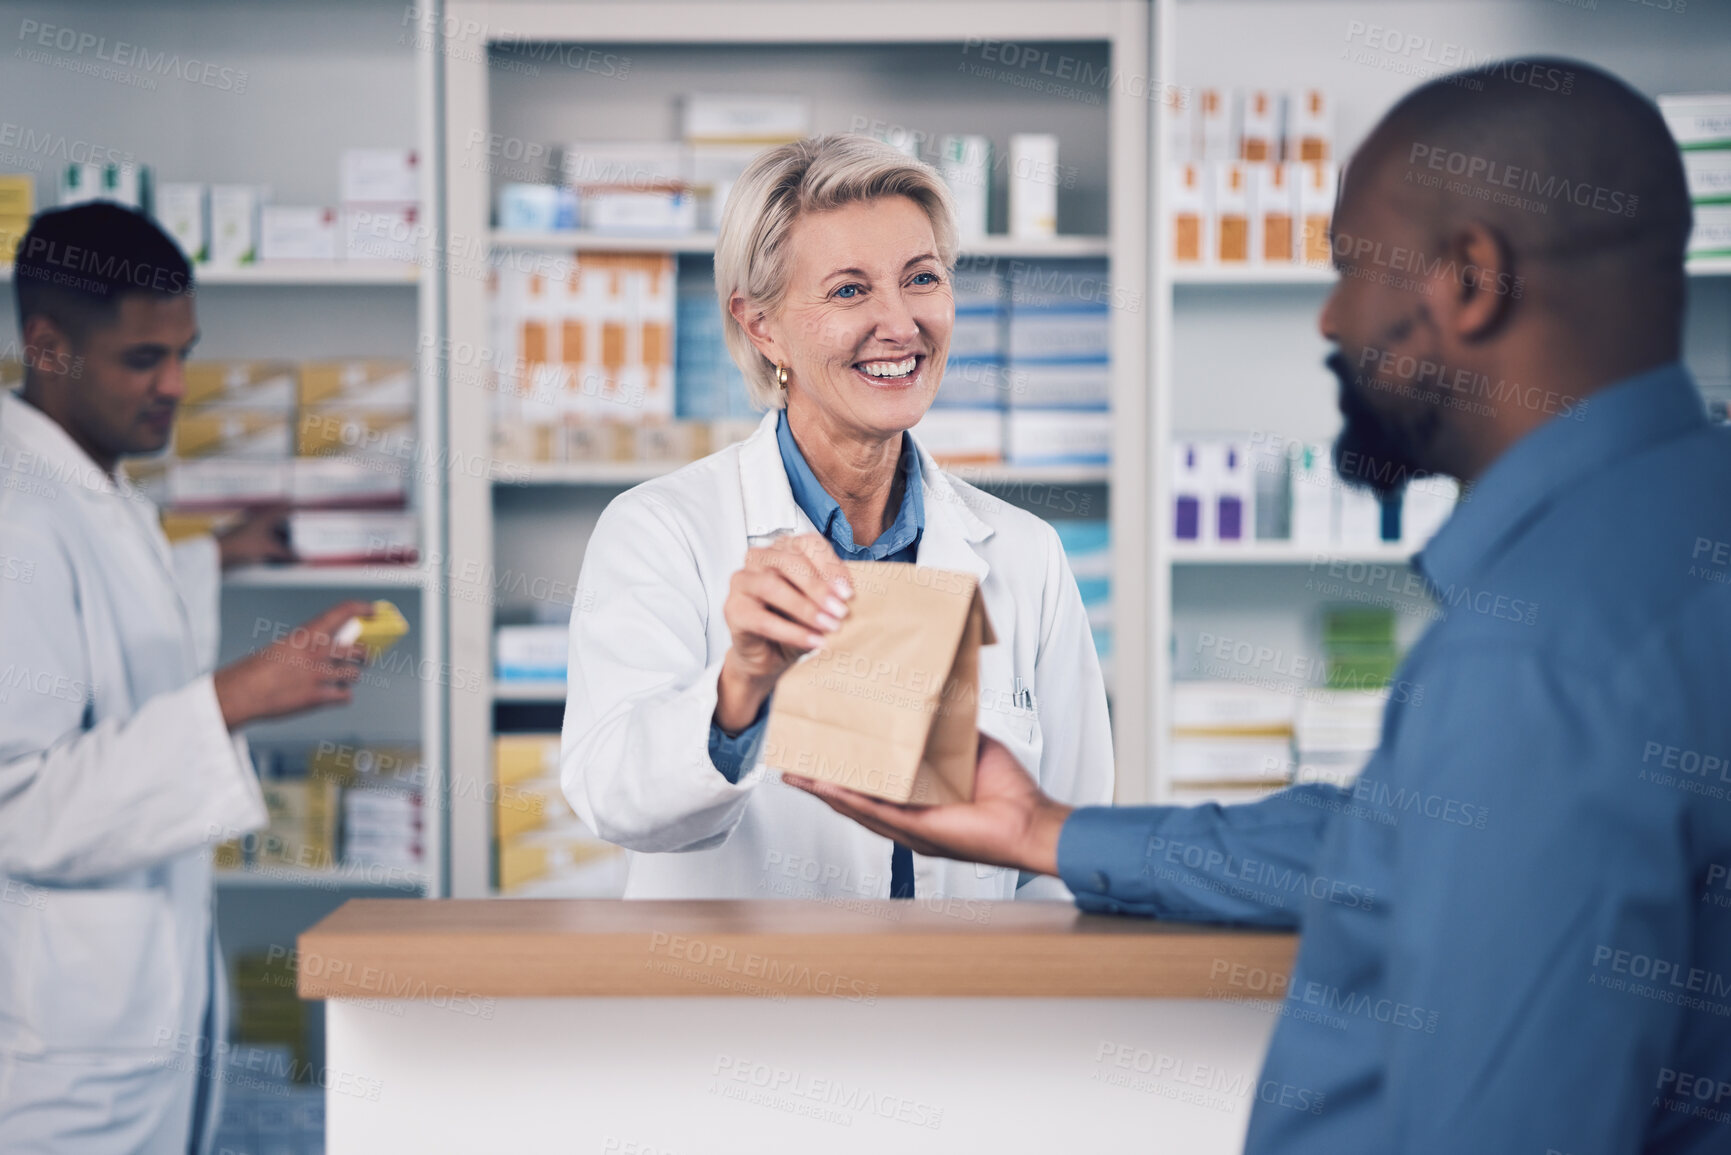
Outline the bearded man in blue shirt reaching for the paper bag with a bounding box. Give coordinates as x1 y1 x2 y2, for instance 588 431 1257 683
795 59 1731 1155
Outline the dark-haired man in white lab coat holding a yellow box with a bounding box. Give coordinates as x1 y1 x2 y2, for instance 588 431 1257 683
0 204 367 1153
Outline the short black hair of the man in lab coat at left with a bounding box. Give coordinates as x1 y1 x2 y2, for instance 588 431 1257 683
12 201 192 345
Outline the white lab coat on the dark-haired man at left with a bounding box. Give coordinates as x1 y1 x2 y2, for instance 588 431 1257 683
0 393 265 1155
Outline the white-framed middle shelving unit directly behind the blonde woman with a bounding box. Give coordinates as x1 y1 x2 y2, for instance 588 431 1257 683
443 0 1151 895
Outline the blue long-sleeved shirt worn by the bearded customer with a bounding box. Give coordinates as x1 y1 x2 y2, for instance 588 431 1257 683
1058 365 1731 1155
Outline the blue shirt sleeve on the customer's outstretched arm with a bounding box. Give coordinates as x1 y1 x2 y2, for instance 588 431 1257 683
1058 783 1347 928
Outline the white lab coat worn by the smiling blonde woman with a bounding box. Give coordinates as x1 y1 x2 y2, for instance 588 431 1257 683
561 412 1113 902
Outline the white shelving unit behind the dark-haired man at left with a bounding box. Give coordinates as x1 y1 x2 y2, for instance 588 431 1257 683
0 0 447 907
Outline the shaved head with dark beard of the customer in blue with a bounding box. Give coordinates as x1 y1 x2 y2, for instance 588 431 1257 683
1322 57 1693 494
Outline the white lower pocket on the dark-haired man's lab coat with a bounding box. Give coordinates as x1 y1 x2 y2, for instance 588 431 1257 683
12 890 183 1053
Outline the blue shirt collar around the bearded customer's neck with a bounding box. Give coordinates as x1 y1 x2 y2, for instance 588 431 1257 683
1414 362 1707 589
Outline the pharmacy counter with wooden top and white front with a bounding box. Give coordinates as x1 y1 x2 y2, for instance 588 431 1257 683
298 899 1303 1155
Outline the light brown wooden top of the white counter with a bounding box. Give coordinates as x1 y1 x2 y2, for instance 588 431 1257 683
298 899 1298 1001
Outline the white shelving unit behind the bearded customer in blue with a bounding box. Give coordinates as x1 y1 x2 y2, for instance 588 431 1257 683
1148 0 1731 798
